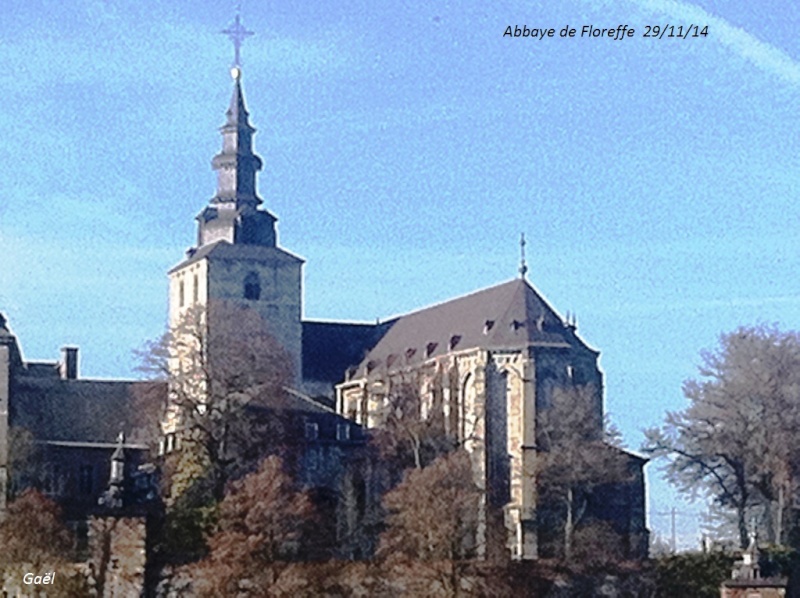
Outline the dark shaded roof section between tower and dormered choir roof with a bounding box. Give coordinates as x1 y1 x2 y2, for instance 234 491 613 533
303 320 397 383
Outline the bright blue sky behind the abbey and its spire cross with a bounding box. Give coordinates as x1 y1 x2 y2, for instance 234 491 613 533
0 0 800 545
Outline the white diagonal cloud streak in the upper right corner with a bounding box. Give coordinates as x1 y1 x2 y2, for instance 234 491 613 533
634 0 800 86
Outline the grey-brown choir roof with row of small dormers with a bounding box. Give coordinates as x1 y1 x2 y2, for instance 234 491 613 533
359 279 588 374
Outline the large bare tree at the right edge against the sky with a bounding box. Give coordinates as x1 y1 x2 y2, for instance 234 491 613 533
645 326 800 548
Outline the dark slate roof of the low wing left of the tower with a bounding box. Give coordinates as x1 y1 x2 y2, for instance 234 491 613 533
9 376 150 443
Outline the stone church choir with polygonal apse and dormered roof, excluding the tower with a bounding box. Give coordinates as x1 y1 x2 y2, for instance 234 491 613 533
337 279 648 559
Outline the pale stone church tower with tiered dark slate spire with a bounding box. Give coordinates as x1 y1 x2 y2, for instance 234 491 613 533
169 63 303 382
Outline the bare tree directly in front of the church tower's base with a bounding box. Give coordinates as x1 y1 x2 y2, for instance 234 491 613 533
140 302 292 501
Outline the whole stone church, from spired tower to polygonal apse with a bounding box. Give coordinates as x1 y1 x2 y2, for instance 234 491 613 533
166 68 648 559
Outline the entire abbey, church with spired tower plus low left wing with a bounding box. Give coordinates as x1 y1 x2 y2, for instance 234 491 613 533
0 49 648 559
